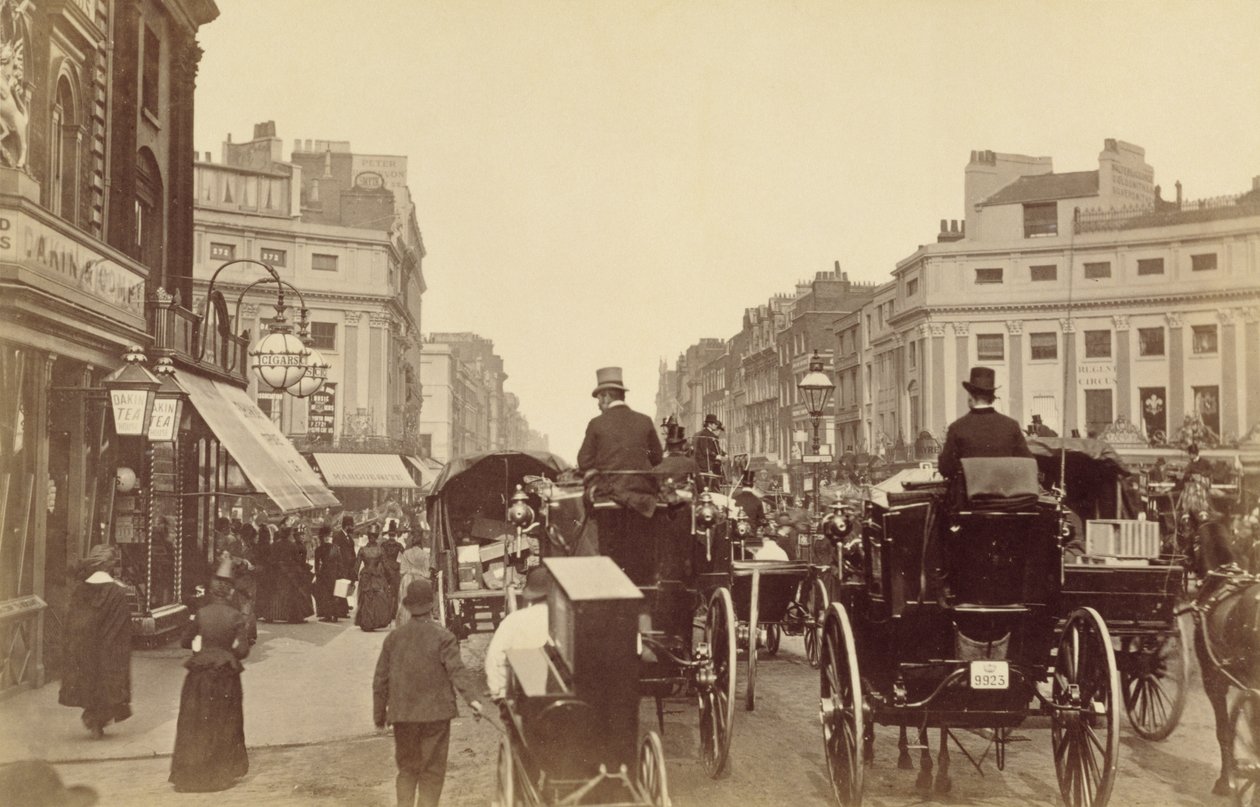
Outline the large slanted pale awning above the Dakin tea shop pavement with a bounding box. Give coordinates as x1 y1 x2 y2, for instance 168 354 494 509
179 372 341 513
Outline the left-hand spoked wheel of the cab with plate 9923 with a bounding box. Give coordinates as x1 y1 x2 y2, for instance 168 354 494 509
819 603 864 807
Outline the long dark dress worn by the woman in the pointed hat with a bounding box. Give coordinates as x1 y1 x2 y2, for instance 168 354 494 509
169 598 249 792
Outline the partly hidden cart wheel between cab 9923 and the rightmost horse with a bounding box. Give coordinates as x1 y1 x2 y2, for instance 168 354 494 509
1120 619 1189 740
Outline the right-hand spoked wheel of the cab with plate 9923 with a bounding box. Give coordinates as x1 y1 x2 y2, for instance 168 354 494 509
1051 608 1120 807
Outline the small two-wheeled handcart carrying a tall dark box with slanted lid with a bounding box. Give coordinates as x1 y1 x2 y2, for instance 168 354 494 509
495 557 669 807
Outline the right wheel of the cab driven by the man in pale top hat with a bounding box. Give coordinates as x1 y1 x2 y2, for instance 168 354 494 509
698 586 736 779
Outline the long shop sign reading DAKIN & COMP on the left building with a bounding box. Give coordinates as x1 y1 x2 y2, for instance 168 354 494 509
0 209 145 318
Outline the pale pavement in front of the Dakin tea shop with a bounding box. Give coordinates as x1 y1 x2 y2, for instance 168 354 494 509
0 619 488 763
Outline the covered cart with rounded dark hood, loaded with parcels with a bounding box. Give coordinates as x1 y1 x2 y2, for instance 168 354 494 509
427 451 568 638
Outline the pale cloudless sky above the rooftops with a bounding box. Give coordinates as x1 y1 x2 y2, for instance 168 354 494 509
197 0 1260 462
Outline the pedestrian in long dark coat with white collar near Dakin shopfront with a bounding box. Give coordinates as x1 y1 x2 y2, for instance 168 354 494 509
58 543 131 739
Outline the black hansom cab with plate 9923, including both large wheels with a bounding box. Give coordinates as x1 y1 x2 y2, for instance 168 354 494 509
819 459 1120 807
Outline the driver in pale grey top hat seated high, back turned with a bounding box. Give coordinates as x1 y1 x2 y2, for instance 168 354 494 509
577 367 664 518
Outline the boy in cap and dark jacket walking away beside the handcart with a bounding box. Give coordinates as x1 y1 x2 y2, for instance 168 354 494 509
372 580 481 807
